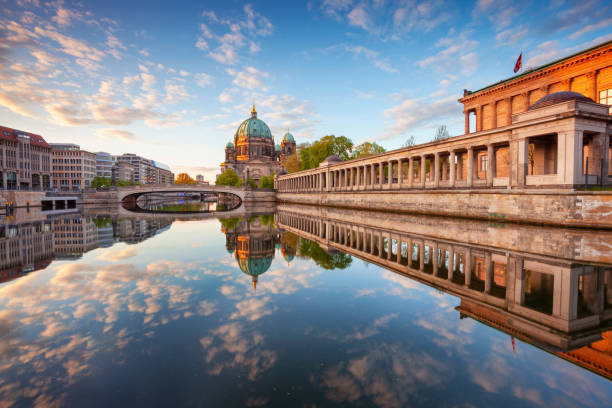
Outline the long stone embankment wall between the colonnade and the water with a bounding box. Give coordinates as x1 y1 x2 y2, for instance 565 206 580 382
276 190 612 228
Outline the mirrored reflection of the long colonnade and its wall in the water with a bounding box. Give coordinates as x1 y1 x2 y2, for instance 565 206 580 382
275 205 612 378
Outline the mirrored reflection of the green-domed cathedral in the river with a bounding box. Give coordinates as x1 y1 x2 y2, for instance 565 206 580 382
219 215 283 290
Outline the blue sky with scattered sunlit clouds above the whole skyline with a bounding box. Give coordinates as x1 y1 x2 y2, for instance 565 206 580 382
0 0 612 180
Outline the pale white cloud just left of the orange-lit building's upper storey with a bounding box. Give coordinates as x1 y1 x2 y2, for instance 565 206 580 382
381 96 461 139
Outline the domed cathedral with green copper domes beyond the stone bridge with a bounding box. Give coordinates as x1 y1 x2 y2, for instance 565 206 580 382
221 105 296 183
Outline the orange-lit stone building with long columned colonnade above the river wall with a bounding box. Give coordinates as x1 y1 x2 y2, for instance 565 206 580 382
276 41 612 192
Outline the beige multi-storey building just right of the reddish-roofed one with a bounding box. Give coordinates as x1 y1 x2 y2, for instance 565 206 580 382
51 143 96 191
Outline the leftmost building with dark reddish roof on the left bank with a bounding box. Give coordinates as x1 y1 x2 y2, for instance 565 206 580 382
0 126 51 191
